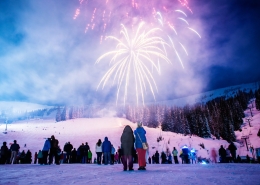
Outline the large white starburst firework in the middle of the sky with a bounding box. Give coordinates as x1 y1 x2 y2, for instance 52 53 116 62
96 23 171 104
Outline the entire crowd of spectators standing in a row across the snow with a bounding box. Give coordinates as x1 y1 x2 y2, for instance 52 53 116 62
0 122 258 171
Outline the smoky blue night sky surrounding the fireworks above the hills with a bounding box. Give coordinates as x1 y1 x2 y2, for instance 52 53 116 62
0 0 260 104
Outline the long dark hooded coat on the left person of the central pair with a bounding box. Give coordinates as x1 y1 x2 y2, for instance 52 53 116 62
121 125 135 156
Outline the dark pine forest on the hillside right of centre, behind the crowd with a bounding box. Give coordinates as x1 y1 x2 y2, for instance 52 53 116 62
126 90 260 141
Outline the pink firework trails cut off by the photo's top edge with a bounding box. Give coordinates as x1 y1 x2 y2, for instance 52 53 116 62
73 0 197 41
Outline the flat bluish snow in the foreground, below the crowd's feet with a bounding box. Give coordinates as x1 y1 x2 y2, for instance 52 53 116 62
0 163 260 185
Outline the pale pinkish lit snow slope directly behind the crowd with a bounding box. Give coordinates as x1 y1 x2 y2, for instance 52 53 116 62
0 118 228 161
